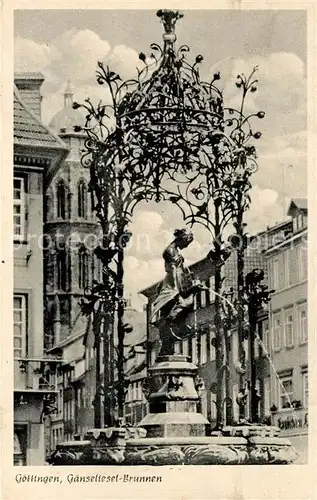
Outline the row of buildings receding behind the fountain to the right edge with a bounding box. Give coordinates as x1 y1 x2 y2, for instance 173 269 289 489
138 203 308 433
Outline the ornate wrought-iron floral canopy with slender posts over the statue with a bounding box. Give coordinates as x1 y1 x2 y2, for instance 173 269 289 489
74 10 265 423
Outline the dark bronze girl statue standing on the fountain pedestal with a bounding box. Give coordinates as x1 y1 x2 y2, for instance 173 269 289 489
152 229 203 356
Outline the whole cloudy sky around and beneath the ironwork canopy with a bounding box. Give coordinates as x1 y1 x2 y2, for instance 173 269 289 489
15 9 307 304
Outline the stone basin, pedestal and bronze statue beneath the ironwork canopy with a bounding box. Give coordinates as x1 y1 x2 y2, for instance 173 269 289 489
49 230 297 465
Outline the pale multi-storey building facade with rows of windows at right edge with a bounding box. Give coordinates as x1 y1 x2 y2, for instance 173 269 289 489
265 199 308 434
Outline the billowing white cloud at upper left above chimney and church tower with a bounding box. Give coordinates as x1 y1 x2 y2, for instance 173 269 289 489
15 29 142 123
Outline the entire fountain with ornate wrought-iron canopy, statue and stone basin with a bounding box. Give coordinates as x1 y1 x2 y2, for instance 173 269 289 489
48 10 296 465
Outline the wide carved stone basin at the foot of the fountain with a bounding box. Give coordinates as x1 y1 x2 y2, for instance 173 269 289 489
48 427 297 466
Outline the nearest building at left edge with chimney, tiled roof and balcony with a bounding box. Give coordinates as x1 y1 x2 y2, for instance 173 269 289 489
13 73 68 465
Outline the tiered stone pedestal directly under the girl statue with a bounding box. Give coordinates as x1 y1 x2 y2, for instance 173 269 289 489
138 354 210 438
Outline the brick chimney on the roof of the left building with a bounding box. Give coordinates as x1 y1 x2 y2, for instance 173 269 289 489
14 73 44 118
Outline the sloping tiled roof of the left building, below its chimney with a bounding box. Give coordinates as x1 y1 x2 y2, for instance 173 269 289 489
13 85 67 151
